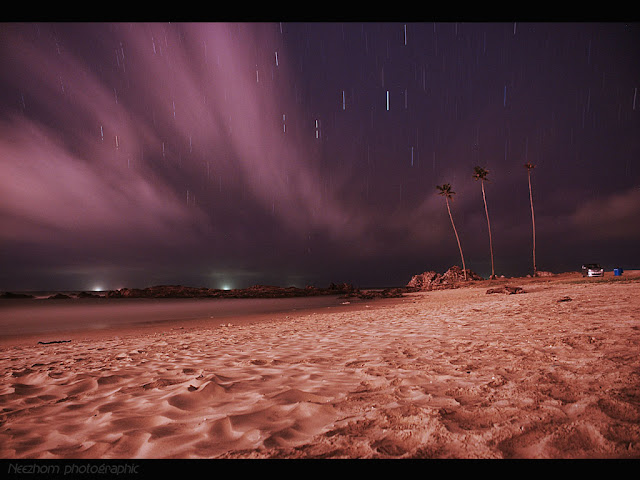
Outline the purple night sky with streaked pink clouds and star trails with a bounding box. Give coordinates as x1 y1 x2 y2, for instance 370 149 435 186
0 22 640 291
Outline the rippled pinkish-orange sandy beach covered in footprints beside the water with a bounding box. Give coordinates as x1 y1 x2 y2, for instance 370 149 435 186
0 271 640 459
